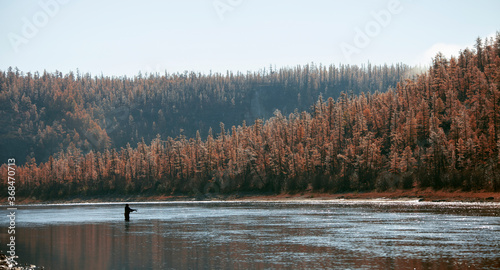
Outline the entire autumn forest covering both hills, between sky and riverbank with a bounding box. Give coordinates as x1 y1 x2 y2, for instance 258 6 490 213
0 33 500 199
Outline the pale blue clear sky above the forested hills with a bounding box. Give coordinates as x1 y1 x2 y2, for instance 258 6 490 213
0 0 500 77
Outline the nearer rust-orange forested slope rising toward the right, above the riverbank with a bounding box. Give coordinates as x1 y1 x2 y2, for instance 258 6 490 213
0 34 500 199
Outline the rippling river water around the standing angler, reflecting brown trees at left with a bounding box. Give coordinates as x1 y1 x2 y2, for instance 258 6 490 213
0 200 500 270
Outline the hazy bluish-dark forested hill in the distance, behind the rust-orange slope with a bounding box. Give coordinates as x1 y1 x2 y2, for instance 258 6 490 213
0 65 414 164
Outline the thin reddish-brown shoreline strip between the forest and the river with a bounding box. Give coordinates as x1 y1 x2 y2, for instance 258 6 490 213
0 188 500 206
